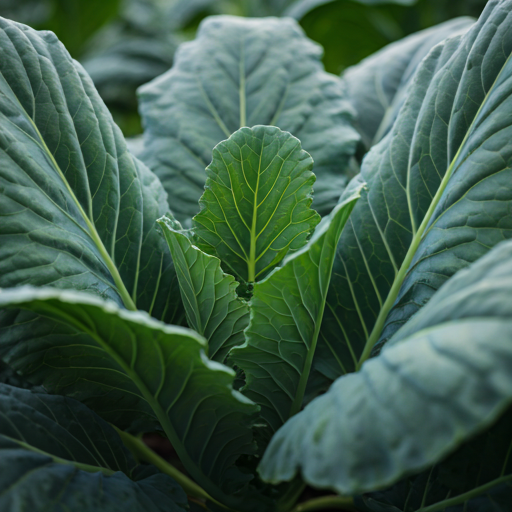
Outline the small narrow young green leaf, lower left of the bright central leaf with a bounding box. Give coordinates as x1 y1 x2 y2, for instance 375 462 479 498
158 217 249 363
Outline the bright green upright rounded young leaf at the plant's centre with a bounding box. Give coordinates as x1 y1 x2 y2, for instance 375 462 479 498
193 126 320 283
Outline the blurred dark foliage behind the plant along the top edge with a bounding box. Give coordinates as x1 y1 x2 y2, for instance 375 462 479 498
0 0 486 136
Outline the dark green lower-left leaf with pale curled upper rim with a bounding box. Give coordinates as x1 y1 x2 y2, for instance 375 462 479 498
0 287 257 506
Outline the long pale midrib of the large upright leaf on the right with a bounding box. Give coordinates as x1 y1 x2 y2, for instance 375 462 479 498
356 48 512 370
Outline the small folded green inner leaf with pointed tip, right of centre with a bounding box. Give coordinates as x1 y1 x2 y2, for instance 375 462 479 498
230 186 360 437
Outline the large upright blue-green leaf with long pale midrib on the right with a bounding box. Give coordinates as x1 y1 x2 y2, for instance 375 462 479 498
319 0 512 379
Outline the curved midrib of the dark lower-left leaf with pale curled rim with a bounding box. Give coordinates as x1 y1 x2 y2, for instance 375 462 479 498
49 311 242 506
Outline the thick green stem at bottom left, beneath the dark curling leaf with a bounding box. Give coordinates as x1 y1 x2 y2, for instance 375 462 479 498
116 425 226 508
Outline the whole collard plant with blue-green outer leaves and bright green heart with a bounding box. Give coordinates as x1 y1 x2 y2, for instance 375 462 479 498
0 0 512 512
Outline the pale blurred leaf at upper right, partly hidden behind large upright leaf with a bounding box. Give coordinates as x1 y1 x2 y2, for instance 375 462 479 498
342 18 475 149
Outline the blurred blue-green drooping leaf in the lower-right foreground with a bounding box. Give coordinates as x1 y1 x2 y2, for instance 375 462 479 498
260 241 512 495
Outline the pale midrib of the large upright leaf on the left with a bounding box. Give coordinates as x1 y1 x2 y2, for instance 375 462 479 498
13 96 137 311
